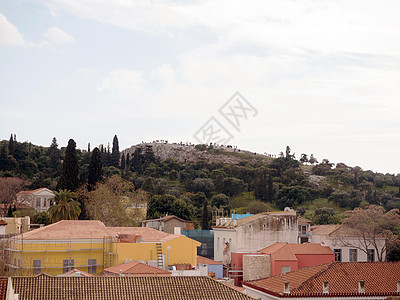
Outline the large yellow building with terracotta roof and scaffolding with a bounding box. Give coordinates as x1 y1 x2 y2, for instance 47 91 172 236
5 220 201 275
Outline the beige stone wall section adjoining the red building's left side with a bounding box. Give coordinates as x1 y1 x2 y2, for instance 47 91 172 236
243 255 271 281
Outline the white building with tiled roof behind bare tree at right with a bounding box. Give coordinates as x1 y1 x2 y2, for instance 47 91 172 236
311 224 386 262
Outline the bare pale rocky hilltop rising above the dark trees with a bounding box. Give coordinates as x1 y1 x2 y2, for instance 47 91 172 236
123 141 274 165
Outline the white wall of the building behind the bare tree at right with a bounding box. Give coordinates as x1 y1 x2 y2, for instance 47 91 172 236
312 235 386 262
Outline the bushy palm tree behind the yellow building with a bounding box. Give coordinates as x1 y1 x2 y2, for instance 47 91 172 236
47 190 81 222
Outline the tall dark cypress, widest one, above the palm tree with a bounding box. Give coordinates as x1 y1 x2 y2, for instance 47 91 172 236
57 139 79 192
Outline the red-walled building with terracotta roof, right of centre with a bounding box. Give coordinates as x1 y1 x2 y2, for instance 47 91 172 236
259 243 335 276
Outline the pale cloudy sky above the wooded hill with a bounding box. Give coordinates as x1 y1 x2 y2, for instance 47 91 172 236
0 0 400 174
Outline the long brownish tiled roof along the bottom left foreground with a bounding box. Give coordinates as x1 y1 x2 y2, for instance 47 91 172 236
12 275 260 300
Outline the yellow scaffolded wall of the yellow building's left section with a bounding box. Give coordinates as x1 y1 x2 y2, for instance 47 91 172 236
8 239 104 276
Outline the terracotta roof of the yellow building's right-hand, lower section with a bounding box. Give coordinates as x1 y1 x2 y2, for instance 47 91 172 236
107 227 181 242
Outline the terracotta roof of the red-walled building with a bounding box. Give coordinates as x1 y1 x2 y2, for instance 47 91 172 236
259 243 333 260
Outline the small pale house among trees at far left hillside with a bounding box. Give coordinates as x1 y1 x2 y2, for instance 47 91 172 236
16 188 55 212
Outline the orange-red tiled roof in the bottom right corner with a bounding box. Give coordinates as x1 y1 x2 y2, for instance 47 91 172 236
244 262 400 297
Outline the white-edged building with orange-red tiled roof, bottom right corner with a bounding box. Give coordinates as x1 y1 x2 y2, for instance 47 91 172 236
243 262 400 300
